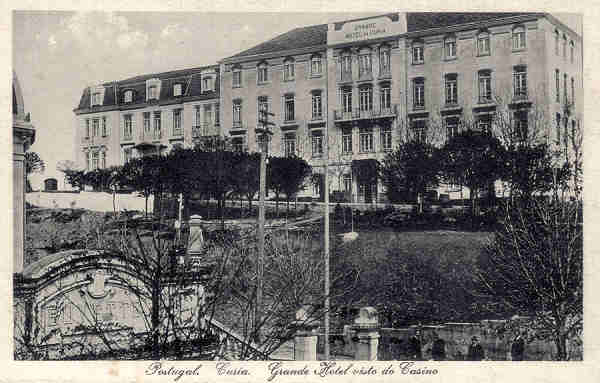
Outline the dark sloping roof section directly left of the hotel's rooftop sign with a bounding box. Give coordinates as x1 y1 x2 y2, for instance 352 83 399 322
229 24 327 59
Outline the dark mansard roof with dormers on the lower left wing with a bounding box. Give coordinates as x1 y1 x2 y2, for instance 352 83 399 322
75 65 219 110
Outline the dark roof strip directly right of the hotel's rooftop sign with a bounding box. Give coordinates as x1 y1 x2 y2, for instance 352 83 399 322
406 12 535 32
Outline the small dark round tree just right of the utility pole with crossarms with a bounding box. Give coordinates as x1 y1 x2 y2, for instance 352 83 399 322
267 156 311 213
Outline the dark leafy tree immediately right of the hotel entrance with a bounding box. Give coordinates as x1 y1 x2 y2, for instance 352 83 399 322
380 140 440 210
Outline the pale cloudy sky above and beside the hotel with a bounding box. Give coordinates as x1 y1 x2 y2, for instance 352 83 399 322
12 11 582 188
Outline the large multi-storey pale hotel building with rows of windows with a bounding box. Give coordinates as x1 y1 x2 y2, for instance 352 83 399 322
74 13 583 202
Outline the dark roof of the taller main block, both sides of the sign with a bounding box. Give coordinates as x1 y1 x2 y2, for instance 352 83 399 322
226 12 536 60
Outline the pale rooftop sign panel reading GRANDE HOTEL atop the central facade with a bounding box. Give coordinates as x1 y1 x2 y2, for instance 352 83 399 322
327 13 406 44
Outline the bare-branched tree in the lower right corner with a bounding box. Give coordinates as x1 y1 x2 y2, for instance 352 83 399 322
478 193 583 360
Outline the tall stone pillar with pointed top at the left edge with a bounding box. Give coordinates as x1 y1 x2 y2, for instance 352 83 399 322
12 72 35 273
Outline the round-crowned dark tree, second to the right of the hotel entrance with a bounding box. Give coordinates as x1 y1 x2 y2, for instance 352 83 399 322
440 129 504 215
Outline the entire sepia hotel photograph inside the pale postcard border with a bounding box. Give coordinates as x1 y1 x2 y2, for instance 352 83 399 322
7 9 589 368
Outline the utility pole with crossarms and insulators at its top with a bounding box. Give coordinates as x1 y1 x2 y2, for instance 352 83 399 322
253 109 275 341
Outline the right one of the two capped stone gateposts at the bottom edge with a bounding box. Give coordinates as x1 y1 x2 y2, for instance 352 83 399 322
352 307 379 360
